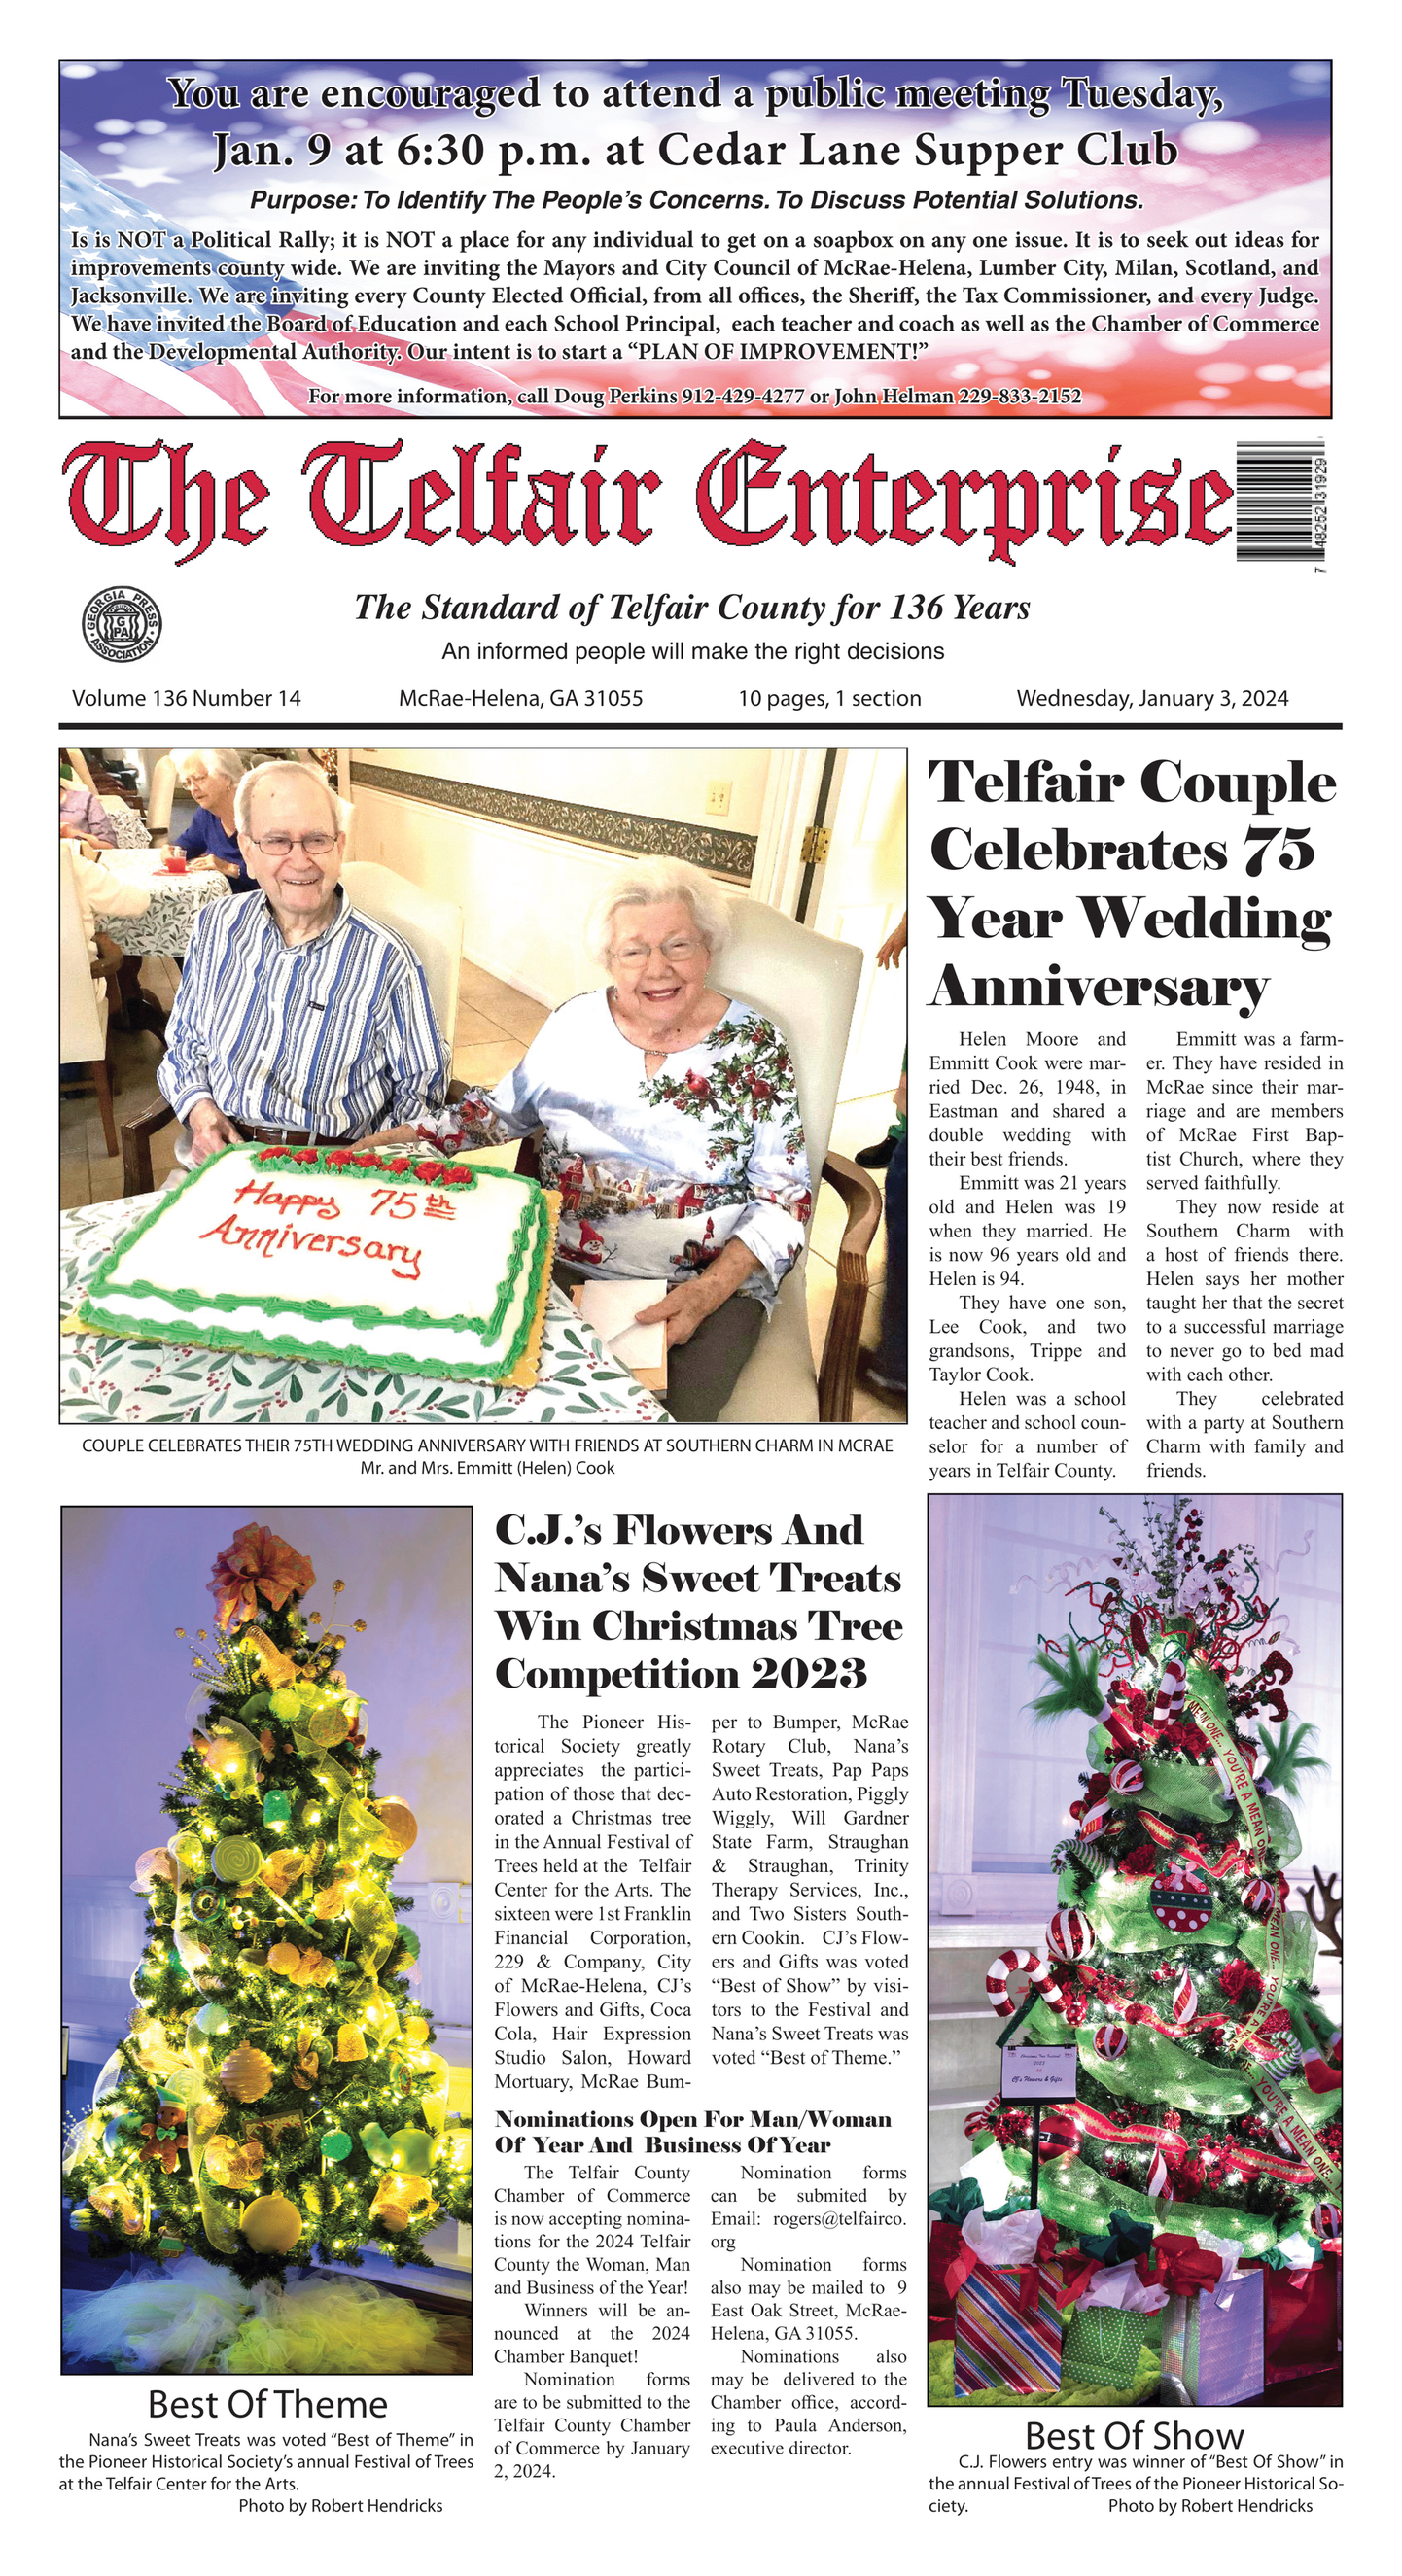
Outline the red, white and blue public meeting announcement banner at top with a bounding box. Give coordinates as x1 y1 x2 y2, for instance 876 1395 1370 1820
59 56 1330 420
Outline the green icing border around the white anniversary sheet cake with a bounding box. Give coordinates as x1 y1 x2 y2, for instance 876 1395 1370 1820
83 1146 549 1380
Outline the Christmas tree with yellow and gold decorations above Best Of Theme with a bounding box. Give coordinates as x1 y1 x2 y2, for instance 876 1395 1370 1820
64 1522 472 2287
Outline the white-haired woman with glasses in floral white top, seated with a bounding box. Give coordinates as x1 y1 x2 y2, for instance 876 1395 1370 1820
399 860 812 1422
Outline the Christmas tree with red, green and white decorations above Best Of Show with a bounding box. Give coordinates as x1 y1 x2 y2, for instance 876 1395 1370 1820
966 1499 1343 2262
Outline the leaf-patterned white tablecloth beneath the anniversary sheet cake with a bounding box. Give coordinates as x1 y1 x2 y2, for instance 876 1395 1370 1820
59 1198 670 1432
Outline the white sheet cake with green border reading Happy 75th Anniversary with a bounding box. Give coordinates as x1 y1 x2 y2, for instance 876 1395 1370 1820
80 1144 559 1386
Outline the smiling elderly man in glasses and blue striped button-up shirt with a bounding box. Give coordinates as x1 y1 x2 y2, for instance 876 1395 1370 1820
158 760 448 1165
